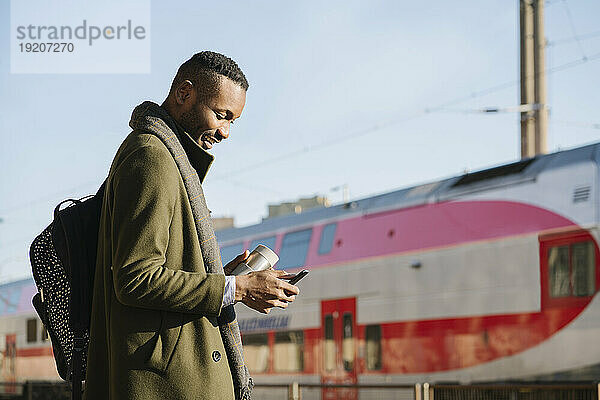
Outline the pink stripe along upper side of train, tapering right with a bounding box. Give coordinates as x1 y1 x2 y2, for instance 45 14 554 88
306 201 577 266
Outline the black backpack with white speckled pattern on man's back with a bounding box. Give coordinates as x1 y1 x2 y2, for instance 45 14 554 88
29 181 106 399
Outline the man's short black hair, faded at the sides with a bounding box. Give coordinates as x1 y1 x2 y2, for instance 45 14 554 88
171 51 250 99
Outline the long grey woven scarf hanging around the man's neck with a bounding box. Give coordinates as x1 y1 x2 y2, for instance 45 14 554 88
129 101 253 400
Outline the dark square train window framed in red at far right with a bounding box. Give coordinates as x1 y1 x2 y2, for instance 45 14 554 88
548 241 596 298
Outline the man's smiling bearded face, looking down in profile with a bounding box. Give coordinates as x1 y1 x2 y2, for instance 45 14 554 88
179 77 246 150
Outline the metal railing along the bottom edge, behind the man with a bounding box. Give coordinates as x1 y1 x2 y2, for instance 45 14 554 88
0 381 600 400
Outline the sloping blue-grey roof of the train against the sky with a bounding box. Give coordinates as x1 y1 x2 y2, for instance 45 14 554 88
217 142 600 243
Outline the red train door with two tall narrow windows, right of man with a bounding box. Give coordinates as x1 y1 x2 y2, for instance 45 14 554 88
321 297 358 400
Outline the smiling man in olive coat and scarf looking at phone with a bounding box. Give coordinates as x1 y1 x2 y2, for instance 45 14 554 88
84 52 298 400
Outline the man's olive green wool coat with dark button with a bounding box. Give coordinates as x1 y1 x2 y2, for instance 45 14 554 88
84 131 234 400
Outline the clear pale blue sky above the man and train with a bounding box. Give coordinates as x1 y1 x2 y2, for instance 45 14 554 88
0 0 600 281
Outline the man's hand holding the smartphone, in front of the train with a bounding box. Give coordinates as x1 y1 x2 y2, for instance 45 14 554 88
235 269 300 314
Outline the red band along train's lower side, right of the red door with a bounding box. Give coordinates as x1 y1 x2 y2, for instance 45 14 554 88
359 307 584 374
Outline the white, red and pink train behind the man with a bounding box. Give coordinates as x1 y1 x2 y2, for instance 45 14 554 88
0 142 600 398
